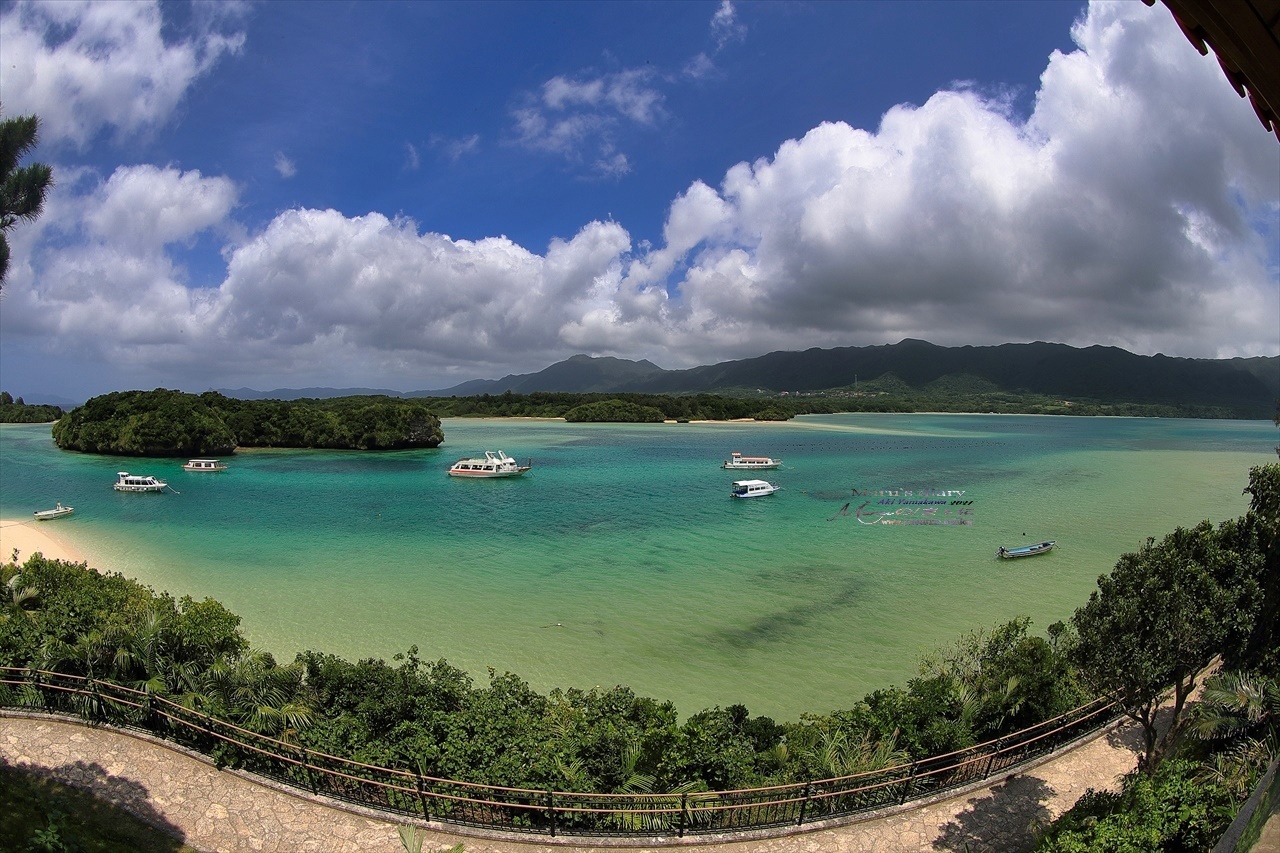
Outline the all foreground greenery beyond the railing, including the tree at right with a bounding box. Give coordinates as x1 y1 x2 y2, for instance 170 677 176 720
0 464 1280 853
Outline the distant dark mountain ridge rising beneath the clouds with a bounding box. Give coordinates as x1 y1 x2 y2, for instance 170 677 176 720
223 338 1280 418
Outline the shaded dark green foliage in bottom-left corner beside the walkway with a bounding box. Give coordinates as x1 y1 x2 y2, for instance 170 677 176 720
0 762 196 853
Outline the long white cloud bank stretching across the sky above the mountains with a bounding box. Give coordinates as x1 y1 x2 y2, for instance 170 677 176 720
0 3 1280 389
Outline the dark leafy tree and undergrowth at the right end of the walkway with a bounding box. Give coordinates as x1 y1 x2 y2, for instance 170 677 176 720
1036 465 1280 853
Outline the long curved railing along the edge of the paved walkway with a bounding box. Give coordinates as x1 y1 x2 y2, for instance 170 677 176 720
0 667 1120 838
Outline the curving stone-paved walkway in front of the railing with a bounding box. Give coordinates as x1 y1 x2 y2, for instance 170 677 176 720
0 716 1137 853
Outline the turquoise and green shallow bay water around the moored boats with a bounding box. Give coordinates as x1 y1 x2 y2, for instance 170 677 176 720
0 415 1277 720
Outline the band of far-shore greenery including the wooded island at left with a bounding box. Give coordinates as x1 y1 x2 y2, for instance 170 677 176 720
0 382 1280 457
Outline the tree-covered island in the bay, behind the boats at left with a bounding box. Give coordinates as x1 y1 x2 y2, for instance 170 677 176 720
52 388 444 456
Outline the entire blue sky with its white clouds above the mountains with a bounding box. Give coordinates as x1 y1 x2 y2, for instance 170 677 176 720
0 0 1280 401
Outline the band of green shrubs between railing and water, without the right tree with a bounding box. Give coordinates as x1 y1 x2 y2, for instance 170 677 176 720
0 556 1082 793
